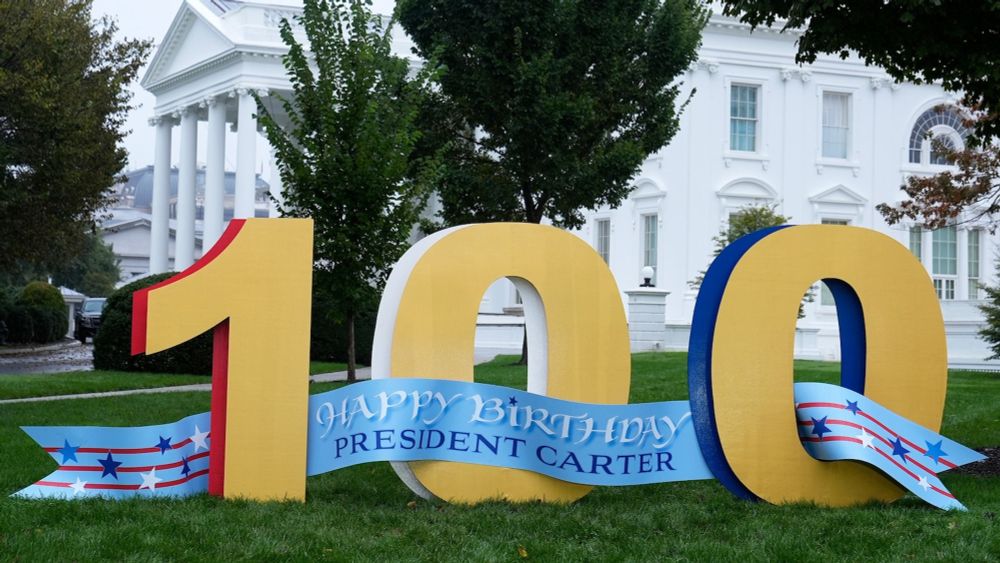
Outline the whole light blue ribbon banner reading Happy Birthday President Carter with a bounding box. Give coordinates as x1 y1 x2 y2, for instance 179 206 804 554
15 379 983 509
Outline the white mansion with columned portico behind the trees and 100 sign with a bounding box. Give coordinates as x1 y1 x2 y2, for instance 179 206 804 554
142 0 997 366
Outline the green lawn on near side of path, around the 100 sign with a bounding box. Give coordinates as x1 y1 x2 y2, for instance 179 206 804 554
0 354 1000 561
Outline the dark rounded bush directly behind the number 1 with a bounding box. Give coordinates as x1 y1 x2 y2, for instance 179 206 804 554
94 273 212 375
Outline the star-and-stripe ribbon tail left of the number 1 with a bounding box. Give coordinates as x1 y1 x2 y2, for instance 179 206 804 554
16 413 211 499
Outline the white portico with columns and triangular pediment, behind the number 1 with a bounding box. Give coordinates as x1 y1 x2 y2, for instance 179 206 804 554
142 0 301 273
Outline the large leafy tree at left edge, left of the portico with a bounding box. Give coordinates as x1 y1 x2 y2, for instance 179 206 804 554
0 0 150 271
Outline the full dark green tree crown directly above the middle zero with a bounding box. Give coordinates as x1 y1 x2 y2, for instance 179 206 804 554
397 0 707 228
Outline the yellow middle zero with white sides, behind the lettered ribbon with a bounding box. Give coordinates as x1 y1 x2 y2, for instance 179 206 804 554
372 223 631 503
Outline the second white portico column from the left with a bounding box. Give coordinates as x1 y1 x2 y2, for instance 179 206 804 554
174 108 198 272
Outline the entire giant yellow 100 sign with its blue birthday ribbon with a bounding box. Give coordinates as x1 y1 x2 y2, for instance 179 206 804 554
11 219 982 509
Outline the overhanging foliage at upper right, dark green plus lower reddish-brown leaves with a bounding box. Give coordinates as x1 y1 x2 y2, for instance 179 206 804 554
723 0 1000 229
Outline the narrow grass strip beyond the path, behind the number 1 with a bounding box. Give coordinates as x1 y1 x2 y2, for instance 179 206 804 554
0 362 347 400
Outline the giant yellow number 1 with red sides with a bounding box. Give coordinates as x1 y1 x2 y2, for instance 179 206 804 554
132 219 312 500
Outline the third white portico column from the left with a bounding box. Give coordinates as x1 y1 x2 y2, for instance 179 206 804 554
201 98 226 249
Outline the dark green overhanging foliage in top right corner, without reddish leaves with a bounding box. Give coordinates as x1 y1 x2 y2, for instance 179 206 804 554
722 0 1000 136
